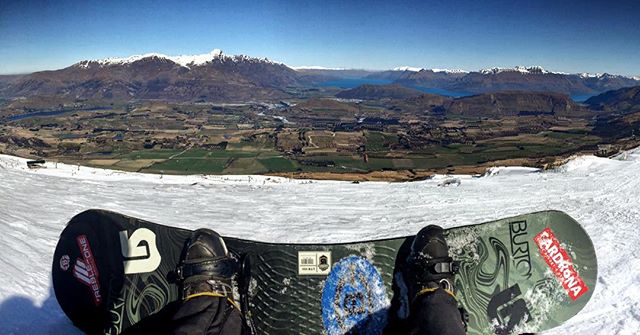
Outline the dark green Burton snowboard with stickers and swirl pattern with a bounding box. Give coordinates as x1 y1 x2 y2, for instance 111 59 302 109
52 210 597 334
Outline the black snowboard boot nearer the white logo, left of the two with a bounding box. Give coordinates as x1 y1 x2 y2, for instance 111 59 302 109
177 229 238 302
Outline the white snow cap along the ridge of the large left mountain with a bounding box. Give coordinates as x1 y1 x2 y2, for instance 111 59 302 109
76 49 274 68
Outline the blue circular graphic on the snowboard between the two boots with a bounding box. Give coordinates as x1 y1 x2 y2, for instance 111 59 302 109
322 256 389 335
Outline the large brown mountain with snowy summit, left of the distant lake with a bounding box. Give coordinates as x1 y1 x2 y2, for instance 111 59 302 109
0 49 306 102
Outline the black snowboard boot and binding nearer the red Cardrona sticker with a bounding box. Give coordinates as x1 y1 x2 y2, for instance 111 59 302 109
405 225 469 331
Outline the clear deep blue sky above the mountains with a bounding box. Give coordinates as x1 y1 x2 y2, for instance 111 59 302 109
0 0 640 75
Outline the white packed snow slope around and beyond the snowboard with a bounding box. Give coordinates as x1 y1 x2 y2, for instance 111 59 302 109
0 149 640 334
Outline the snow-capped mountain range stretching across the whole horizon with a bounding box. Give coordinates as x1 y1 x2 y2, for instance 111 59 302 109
0 50 640 102
